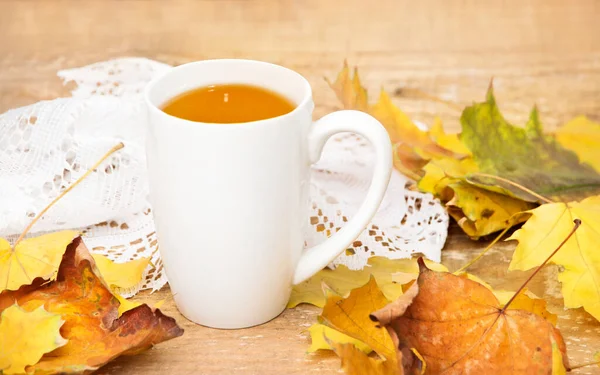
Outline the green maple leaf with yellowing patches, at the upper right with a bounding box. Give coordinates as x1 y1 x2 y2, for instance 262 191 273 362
460 86 600 202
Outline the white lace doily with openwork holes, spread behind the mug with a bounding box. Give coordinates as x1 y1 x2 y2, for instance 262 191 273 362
0 58 448 296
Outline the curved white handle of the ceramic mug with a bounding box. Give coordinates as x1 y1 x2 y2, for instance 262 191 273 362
293 110 392 285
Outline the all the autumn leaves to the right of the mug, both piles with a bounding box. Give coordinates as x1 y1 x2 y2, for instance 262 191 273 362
290 65 600 375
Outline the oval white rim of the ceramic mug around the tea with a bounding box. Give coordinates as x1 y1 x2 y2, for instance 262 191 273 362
144 59 312 128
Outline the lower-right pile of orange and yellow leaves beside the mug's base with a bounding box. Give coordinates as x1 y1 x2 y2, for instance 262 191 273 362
290 231 580 375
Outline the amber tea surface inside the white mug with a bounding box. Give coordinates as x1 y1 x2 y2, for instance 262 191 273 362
162 84 296 124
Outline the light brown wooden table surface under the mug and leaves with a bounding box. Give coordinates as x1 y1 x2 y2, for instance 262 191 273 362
0 0 600 374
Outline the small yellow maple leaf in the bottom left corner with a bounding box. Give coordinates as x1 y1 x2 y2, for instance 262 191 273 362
0 304 67 375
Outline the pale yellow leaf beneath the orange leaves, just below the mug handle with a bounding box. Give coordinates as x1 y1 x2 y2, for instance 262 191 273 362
288 257 447 308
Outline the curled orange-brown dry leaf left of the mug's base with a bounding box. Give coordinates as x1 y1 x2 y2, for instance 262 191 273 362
0 237 183 374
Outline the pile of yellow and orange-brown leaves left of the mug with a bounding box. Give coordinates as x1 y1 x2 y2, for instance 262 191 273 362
0 145 183 374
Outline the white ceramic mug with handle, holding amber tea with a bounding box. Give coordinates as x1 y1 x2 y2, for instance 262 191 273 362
145 60 392 328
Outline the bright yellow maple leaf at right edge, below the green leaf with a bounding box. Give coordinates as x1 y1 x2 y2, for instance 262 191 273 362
509 196 600 320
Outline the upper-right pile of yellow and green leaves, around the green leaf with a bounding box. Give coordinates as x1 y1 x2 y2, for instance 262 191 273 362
330 64 600 319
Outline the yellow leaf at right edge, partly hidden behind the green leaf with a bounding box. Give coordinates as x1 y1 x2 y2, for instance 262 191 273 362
555 116 600 172
